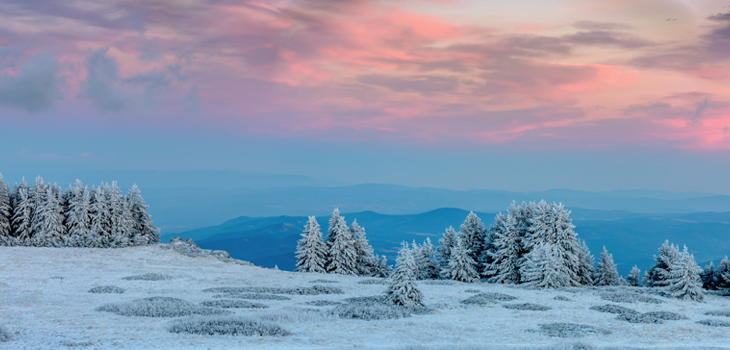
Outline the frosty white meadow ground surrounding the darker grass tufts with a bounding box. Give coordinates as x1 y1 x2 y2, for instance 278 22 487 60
0 246 730 349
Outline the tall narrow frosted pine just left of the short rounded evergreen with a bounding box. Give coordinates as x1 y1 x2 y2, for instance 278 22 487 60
483 212 523 284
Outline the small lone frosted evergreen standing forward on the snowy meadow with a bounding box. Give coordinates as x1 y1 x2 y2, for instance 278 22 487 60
385 242 423 306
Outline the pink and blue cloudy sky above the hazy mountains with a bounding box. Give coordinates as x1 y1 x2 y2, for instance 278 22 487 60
0 0 730 194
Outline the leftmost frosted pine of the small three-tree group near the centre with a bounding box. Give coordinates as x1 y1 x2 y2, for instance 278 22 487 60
294 216 327 273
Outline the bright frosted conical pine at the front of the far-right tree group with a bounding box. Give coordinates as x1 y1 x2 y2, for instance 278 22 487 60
667 246 705 301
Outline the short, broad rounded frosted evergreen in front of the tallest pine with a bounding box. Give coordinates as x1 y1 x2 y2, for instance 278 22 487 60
521 243 575 288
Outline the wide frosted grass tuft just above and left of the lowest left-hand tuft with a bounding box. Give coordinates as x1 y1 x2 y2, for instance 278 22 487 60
96 297 231 317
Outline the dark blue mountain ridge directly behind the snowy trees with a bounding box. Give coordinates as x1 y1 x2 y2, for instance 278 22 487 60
162 208 730 275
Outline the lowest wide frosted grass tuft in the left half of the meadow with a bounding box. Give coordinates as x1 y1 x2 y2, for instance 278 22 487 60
168 316 292 336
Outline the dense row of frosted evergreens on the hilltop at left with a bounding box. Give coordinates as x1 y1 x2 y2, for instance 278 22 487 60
0 174 160 248
